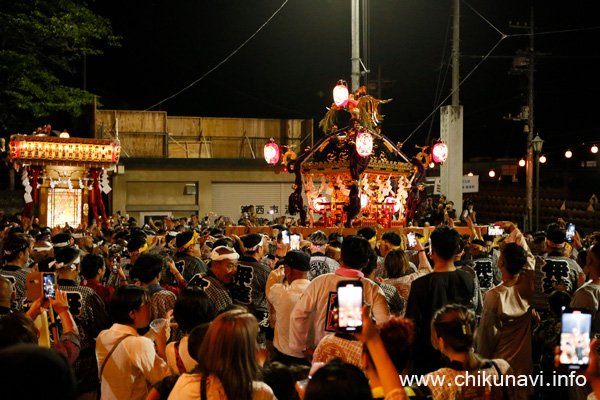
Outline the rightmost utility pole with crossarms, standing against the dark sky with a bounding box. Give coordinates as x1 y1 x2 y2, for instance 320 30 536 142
508 7 536 230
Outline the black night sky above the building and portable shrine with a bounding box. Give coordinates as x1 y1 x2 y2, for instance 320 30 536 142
87 0 600 159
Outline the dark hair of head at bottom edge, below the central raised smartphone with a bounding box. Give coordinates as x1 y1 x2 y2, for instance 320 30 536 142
304 360 373 400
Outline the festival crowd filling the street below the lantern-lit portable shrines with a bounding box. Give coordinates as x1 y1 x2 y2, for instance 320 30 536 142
0 208 600 400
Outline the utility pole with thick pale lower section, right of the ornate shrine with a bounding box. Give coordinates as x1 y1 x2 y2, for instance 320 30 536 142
440 0 464 215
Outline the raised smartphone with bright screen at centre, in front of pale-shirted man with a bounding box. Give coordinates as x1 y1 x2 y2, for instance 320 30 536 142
337 280 363 332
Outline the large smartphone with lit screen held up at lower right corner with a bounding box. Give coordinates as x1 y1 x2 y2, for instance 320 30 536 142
560 309 592 369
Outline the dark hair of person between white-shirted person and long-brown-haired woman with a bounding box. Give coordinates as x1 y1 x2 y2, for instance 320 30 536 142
173 286 214 332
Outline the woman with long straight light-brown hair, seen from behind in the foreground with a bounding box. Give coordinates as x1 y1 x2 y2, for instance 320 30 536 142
169 310 275 400
